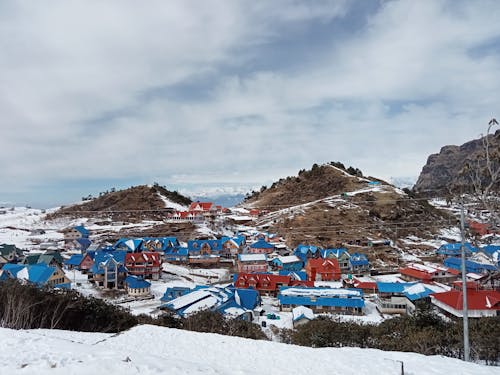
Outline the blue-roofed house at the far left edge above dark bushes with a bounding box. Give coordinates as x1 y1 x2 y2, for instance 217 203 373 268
2 263 71 288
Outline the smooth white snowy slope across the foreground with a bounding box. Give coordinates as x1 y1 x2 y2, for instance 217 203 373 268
0 326 500 375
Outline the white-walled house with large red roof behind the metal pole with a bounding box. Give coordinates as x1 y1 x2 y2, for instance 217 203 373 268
431 284 500 318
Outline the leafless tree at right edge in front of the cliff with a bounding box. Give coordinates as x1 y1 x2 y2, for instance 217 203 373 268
464 118 500 225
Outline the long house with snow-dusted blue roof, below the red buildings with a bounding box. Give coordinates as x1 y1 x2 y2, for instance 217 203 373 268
278 287 365 315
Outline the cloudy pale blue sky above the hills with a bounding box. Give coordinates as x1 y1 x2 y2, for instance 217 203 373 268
0 0 500 207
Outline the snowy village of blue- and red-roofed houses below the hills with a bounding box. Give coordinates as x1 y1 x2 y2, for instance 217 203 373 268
0 197 500 337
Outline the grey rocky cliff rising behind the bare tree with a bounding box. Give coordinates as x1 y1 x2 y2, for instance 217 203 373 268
413 130 500 194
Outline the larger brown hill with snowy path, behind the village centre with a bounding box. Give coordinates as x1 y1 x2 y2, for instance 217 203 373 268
242 163 454 264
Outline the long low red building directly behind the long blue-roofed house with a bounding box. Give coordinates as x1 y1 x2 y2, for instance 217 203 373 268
234 273 314 296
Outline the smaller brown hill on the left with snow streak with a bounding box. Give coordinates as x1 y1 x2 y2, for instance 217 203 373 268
48 184 191 220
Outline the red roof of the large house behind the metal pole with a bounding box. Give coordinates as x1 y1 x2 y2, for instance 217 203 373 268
433 290 500 310
